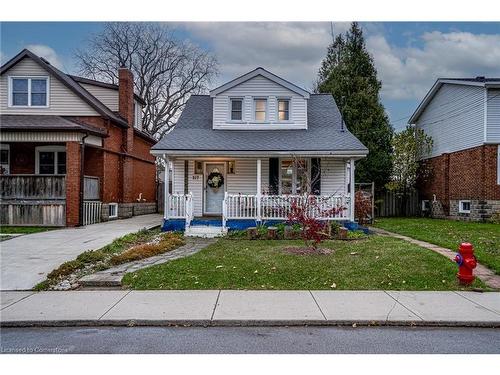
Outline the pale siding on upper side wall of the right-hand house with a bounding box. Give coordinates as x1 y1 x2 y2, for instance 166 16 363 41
416 84 484 157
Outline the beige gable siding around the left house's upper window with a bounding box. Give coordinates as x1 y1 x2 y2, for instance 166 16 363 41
0 58 99 116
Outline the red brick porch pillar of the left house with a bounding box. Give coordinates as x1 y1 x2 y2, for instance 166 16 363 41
66 142 81 227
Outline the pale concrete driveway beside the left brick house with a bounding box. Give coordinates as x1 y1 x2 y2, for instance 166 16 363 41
0 214 162 290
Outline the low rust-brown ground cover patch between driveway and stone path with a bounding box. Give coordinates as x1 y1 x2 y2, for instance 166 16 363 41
110 233 185 265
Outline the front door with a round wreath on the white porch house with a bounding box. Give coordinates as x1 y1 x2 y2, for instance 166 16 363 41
205 163 226 215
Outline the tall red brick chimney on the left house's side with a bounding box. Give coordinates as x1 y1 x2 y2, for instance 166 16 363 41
118 68 134 152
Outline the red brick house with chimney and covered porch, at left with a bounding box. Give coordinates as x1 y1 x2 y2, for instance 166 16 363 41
0 49 157 226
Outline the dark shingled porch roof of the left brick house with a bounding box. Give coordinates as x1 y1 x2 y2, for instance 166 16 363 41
0 115 106 136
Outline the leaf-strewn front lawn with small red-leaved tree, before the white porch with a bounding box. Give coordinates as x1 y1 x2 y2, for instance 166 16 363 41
123 236 484 290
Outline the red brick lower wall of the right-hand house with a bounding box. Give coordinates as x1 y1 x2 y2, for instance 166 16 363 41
419 145 500 204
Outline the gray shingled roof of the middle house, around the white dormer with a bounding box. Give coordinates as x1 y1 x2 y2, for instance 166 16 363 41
153 94 368 153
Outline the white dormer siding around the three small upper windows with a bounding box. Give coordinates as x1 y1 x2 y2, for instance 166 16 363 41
213 76 307 129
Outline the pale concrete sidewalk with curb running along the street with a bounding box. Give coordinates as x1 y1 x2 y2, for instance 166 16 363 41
0 290 500 327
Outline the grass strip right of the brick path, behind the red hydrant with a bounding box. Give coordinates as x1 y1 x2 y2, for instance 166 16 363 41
375 218 500 274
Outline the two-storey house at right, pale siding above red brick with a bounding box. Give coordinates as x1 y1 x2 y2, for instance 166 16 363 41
409 77 500 220
